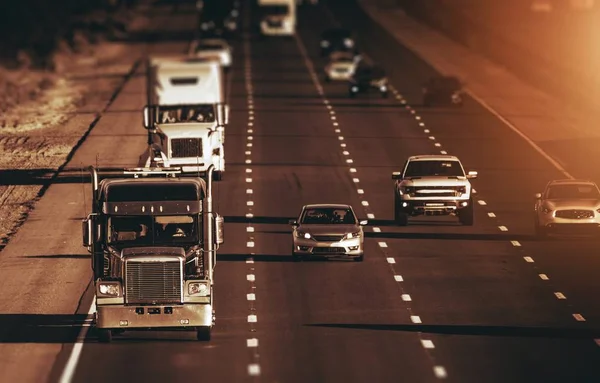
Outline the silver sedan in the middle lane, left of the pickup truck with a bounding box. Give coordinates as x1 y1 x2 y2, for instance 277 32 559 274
290 204 367 262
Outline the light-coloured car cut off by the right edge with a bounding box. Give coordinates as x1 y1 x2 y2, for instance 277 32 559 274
534 179 600 237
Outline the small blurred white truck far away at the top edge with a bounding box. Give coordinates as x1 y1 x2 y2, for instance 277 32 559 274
258 0 296 36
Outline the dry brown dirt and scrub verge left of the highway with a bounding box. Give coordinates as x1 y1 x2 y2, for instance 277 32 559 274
0 12 146 250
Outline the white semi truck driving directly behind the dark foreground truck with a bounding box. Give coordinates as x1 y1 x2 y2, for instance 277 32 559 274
140 56 229 181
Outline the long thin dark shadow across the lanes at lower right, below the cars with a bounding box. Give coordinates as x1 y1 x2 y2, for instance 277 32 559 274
305 323 600 339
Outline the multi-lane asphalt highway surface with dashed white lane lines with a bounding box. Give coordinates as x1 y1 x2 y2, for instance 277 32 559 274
0 2 600 382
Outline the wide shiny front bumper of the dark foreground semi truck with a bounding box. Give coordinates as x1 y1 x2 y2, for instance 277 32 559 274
96 303 213 330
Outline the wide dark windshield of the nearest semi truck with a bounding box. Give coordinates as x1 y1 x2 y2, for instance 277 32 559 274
106 215 199 246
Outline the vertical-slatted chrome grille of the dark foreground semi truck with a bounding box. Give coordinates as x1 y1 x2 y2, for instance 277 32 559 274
125 259 183 304
